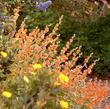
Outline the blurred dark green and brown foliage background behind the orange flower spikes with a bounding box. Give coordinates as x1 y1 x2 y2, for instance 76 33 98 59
1 0 110 76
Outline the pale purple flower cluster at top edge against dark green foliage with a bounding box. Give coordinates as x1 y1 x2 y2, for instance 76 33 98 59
36 0 52 11
